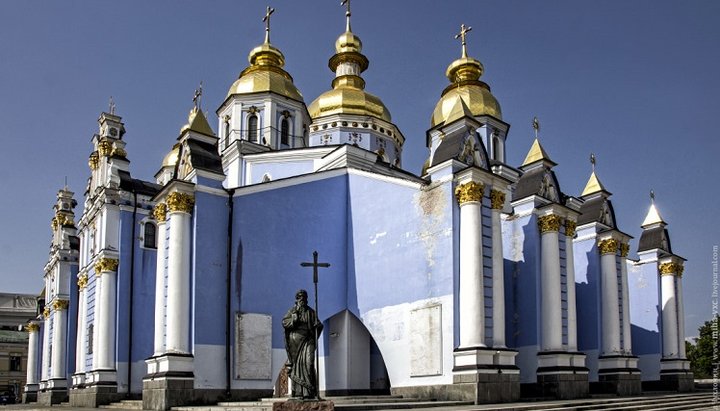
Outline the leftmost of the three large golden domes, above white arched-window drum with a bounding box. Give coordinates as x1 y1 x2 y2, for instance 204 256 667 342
227 43 303 102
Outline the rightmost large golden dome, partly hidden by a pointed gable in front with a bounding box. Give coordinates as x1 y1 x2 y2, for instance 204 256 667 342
430 57 502 127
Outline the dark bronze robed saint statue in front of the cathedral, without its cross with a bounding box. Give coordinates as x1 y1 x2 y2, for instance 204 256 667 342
283 290 323 399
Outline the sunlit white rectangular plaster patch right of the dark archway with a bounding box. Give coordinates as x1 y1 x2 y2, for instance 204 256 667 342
410 305 442 377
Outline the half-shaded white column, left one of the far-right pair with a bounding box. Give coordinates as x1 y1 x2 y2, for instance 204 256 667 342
660 263 679 358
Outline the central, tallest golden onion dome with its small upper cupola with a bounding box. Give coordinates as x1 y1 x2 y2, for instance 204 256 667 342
308 30 391 122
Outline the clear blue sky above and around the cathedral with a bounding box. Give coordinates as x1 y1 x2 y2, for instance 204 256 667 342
0 0 720 335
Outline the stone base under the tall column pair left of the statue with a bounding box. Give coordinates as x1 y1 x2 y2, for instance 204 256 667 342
143 353 195 410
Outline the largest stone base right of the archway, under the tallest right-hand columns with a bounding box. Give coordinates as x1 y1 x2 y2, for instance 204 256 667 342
452 347 520 404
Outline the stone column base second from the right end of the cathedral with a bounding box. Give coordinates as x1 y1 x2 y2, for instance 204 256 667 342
592 355 642 396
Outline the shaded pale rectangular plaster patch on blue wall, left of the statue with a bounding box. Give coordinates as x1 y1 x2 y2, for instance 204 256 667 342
235 313 272 380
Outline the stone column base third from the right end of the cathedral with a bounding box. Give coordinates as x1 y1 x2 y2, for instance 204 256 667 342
533 351 590 400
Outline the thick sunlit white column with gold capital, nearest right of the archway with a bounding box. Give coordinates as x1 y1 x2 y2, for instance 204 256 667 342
455 181 485 348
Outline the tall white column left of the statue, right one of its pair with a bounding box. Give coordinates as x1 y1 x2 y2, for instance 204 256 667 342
166 192 194 353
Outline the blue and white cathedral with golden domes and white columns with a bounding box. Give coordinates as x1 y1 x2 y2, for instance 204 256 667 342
24 5 693 410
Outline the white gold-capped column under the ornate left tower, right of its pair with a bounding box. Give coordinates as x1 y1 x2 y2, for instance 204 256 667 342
93 258 118 370
